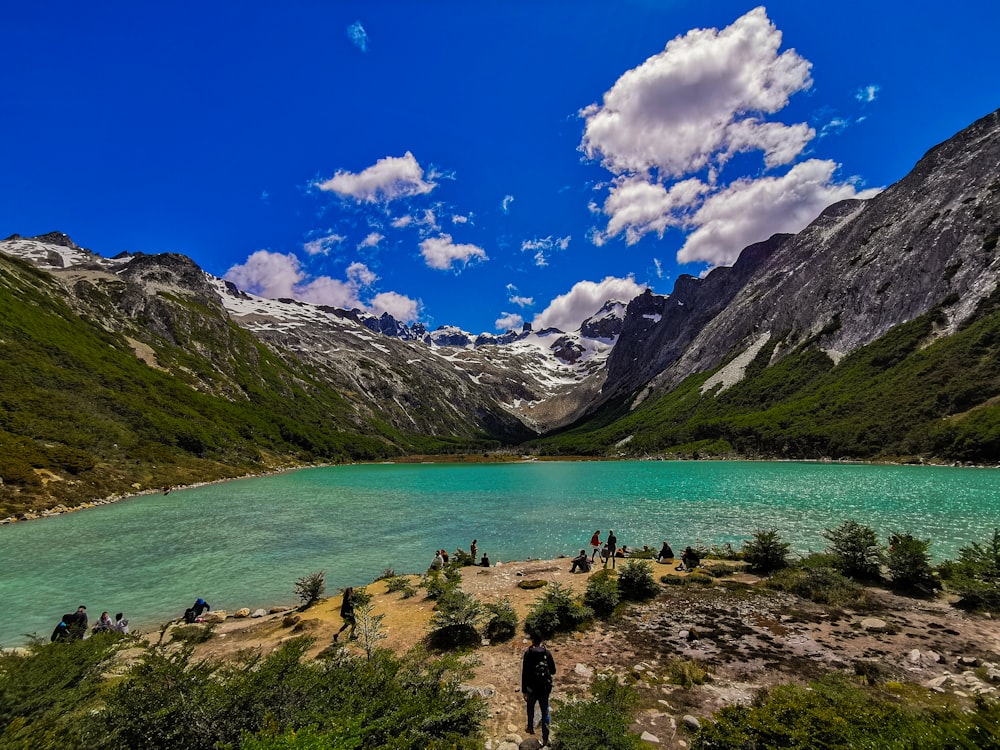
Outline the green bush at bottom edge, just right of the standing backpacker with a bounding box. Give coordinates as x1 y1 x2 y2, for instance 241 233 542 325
552 676 641 750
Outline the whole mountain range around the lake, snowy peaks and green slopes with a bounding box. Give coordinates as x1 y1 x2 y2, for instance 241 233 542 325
0 107 1000 517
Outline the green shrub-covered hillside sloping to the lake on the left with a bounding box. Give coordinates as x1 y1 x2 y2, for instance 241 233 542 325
0 257 494 518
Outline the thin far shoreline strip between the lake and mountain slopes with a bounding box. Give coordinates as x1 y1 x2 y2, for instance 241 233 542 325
0 454 1000 526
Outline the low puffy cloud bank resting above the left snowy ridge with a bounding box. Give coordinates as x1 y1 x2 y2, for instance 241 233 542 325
225 250 419 323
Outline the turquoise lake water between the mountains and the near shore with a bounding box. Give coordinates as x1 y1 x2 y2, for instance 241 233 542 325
0 461 1000 646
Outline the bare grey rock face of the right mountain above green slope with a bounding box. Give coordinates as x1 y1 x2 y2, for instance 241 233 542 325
602 107 1000 400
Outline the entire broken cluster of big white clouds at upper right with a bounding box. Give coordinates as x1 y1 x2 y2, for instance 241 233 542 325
580 7 877 264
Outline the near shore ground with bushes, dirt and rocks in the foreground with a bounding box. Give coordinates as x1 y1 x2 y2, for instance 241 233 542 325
0 521 1000 750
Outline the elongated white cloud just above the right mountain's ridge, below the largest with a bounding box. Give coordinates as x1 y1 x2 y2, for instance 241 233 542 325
677 159 878 266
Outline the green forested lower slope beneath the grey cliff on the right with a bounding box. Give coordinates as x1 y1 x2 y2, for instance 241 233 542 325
533 293 1000 463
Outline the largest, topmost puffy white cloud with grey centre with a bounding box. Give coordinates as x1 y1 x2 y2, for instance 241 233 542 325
580 7 812 177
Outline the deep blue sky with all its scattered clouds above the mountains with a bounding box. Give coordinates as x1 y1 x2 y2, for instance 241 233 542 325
0 0 1000 333
